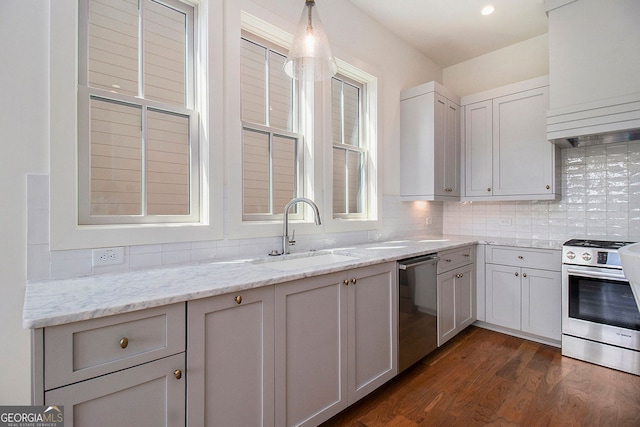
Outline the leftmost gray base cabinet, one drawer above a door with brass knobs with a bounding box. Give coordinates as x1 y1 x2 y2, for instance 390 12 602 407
34 303 186 427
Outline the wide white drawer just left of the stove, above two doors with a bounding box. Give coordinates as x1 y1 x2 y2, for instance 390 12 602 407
486 246 562 271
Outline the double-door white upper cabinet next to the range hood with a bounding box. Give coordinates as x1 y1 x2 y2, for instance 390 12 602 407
462 77 560 201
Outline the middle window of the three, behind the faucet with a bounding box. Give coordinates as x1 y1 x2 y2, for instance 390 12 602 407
240 33 303 221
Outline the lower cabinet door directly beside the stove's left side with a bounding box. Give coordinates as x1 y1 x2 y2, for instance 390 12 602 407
522 268 562 341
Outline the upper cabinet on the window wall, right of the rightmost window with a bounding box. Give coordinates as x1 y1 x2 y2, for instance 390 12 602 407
400 82 461 200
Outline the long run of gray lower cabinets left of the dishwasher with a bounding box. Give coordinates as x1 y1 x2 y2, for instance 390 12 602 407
33 262 397 427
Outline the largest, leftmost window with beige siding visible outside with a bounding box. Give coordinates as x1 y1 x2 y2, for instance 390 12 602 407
78 0 200 224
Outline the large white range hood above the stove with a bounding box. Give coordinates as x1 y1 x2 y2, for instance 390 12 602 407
545 0 640 147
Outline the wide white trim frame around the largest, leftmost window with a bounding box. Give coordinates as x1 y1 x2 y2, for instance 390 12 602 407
48 0 225 251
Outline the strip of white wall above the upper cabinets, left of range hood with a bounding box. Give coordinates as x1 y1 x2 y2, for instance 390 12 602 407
442 34 549 97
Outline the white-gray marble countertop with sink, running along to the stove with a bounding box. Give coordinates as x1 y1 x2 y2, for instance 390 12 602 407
22 236 561 329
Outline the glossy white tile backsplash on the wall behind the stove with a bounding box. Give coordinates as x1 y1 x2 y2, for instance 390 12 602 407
443 141 640 241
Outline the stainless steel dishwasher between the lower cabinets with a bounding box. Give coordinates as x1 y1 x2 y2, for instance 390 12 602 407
398 254 439 373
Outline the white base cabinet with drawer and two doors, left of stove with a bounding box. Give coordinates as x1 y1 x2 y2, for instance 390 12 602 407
485 246 562 345
